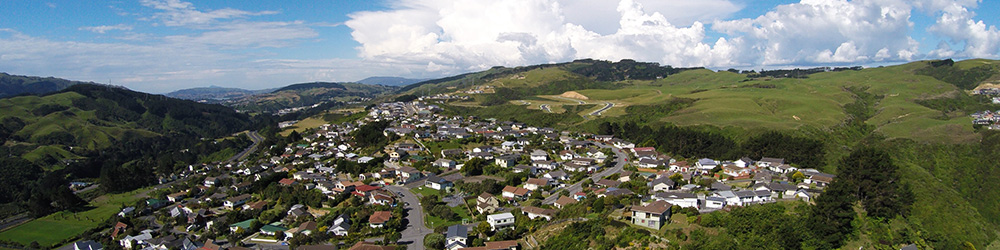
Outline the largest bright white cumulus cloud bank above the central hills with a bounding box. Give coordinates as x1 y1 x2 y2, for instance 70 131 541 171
345 0 739 72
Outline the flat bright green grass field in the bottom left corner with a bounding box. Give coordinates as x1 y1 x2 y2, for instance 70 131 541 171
0 188 148 247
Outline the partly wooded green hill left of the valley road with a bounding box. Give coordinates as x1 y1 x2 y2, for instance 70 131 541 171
0 84 251 166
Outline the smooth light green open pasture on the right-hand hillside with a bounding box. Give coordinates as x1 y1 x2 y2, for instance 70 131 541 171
492 61 993 143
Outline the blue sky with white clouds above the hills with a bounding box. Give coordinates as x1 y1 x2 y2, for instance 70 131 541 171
0 0 1000 93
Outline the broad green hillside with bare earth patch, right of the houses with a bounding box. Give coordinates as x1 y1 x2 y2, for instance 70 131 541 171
412 59 1000 249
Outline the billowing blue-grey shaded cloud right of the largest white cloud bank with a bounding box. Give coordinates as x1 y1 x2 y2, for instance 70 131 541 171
713 0 918 65
